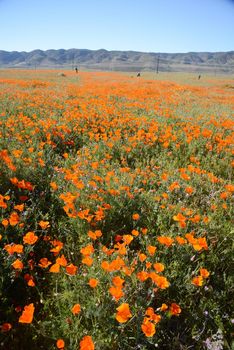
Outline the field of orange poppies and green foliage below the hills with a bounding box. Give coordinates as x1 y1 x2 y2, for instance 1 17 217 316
0 70 234 350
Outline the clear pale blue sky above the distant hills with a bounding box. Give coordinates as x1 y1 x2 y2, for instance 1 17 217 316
0 0 234 52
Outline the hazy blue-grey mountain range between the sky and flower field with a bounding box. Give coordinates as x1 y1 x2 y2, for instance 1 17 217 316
0 49 234 74
